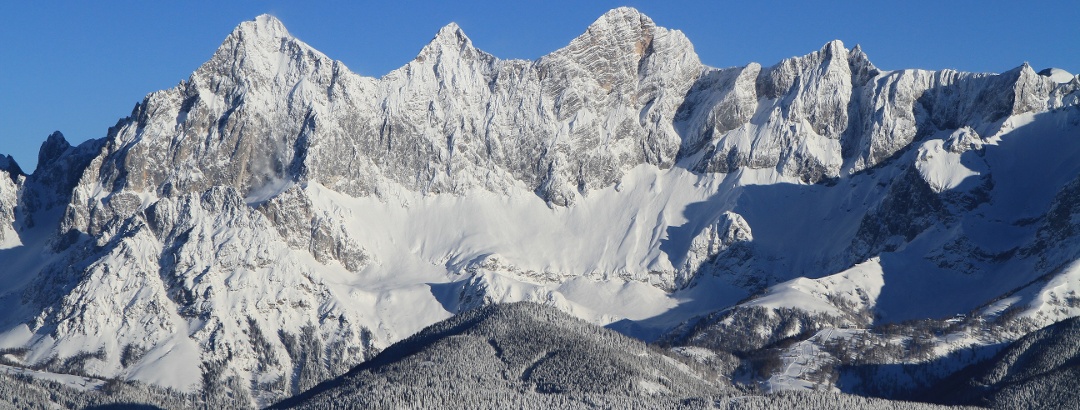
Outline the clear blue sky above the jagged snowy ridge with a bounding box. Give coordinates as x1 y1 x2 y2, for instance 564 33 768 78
0 0 1080 172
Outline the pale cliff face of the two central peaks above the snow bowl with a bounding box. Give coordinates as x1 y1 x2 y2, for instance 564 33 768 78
307 9 702 206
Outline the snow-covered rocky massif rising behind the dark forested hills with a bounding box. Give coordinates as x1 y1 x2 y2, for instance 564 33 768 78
0 8 1080 404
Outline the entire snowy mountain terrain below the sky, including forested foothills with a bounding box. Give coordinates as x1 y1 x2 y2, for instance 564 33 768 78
0 8 1080 409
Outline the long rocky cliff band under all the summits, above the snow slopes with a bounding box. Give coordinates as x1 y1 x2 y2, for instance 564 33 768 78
56 9 1064 232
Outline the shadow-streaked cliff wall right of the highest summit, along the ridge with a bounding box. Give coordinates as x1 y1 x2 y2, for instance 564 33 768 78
679 41 1076 182
